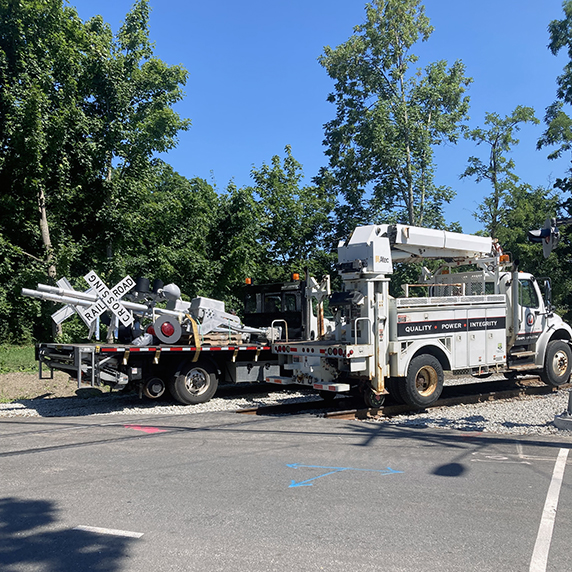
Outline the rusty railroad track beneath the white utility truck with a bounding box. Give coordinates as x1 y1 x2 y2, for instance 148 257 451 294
237 377 572 419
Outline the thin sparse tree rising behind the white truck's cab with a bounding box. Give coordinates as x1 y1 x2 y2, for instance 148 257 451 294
461 105 540 238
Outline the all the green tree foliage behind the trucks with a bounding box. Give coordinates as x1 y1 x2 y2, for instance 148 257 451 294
4 0 572 342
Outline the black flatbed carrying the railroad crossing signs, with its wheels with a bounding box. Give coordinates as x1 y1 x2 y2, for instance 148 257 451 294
36 343 280 404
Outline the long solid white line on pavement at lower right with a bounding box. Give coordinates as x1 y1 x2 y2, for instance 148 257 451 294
529 449 570 572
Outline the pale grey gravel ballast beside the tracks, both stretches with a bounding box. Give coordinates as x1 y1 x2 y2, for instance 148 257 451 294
0 380 572 435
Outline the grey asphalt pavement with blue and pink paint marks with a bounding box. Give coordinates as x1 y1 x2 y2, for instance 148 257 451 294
0 412 572 572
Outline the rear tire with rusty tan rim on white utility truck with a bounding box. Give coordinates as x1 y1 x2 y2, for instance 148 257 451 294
401 354 444 407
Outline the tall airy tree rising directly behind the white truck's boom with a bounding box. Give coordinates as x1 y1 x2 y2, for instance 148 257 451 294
319 0 471 232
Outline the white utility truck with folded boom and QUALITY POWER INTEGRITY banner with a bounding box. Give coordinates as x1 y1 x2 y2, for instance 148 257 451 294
266 224 572 408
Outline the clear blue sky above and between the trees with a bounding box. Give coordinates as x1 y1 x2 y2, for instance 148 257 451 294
69 0 570 232
